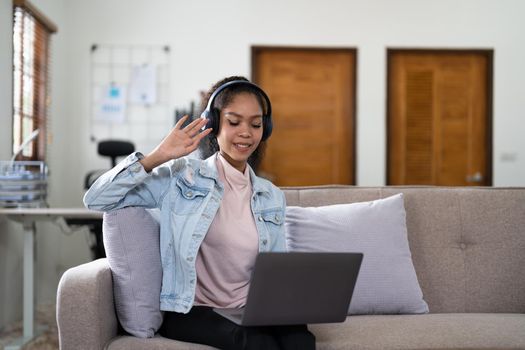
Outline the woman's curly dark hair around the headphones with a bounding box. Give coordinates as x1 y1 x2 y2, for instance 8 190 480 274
199 76 266 171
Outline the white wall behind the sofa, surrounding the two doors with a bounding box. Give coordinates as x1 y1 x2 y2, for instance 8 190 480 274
0 0 525 328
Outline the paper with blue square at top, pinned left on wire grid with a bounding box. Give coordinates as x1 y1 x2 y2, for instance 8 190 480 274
96 84 126 123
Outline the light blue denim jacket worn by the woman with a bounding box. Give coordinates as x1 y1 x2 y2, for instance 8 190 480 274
84 152 286 313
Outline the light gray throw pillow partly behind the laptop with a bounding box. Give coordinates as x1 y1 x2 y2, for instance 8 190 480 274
285 194 428 314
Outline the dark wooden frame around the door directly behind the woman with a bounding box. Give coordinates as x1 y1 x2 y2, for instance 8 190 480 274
251 45 358 185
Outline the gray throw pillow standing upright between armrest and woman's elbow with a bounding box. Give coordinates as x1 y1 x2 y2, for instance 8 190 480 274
103 207 162 338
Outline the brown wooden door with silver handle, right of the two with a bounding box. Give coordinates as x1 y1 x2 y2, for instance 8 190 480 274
387 50 492 186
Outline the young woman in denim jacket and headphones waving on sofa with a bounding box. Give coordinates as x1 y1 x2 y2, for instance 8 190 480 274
84 77 315 349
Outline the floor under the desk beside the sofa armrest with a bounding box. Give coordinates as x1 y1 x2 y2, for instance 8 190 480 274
0 304 58 350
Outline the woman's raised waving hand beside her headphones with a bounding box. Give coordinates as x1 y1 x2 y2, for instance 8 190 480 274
140 115 212 172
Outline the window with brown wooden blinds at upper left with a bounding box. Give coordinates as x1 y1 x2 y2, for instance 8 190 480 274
13 0 57 160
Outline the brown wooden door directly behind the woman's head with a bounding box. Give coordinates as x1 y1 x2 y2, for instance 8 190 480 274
252 47 356 186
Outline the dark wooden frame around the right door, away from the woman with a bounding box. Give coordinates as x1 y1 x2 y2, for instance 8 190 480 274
385 48 494 186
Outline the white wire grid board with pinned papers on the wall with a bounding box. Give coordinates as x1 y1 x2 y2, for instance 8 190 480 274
89 44 170 151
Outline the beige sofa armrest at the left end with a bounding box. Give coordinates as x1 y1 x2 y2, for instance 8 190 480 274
57 259 118 350
